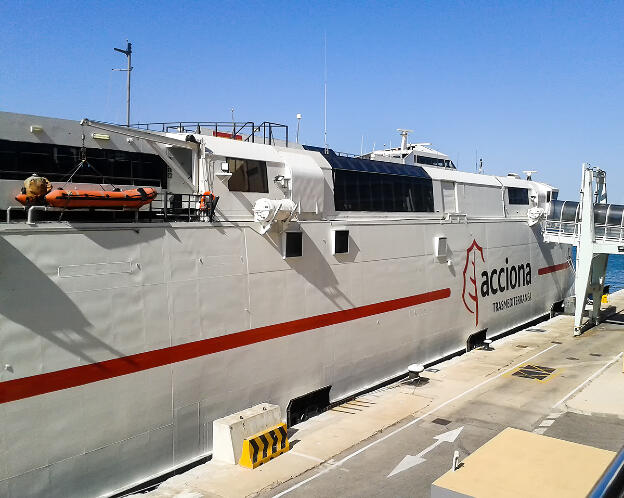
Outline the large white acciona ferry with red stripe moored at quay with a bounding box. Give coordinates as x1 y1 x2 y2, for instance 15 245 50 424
0 112 572 497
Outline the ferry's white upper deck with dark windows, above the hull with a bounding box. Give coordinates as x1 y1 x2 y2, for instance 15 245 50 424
0 112 557 227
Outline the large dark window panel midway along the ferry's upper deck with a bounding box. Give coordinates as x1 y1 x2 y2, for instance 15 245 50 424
333 170 433 213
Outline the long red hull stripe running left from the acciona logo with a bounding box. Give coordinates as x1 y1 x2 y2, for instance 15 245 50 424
0 288 451 404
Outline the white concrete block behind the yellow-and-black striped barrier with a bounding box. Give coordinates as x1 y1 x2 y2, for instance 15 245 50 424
212 403 282 465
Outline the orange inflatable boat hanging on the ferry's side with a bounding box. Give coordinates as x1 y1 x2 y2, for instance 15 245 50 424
42 187 157 209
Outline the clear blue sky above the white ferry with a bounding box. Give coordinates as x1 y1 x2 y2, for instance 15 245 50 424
0 0 624 203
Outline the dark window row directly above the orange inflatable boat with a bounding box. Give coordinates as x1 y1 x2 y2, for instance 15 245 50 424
0 140 167 188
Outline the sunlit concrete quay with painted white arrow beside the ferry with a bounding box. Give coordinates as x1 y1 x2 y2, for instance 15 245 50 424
140 291 624 498
